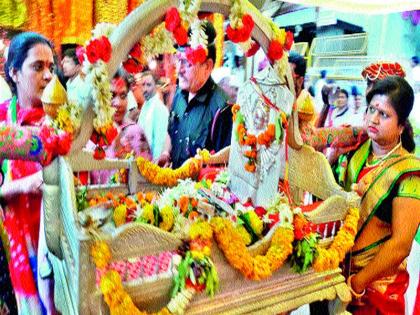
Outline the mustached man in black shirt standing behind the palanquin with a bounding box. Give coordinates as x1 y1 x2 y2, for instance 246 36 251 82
168 21 232 168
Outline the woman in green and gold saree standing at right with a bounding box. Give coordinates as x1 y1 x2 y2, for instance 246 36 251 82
337 76 420 314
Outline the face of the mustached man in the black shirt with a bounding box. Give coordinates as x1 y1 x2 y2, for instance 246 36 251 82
177 52 213 93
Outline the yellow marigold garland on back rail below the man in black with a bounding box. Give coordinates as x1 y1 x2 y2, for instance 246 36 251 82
137 157 201 187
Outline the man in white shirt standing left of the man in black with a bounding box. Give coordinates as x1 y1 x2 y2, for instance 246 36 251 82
137 71 169 161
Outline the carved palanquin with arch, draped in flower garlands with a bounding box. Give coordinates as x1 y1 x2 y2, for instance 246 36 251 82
0 1 359 314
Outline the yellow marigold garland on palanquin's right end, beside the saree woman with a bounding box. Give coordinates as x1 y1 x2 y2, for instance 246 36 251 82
312 208 359 272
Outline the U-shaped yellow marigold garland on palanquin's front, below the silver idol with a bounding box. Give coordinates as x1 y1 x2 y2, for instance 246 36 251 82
211 217 294 280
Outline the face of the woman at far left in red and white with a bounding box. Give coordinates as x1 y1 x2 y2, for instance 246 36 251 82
11 44 54 106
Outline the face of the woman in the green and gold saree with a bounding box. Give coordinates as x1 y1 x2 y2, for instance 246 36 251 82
365 95 403 145
